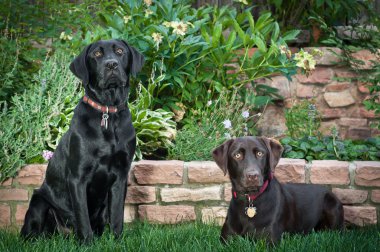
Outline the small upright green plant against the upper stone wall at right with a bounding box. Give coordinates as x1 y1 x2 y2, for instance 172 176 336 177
285 100 321 138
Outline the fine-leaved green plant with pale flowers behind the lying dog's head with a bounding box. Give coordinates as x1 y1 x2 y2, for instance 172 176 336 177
168 89 261 161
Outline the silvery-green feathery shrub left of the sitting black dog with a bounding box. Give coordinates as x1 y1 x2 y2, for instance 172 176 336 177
0 53 80 181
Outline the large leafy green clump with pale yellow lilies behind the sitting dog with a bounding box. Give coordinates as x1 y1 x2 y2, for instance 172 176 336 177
60 0 297 110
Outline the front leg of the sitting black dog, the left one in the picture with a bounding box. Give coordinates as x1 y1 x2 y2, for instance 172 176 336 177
68 176 93 243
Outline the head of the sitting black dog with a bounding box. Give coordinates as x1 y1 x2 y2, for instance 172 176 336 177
70 40 144 105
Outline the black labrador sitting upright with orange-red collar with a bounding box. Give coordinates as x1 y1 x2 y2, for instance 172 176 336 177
21 40 144 242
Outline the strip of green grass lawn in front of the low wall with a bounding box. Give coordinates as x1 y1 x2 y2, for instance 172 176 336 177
0 223 380 252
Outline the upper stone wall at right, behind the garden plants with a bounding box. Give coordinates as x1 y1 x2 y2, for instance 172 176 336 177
258 47 380 139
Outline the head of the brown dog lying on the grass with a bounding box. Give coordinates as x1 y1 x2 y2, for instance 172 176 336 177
212 137 283 191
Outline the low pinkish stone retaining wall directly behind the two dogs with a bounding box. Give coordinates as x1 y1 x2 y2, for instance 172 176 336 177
0 158 380 227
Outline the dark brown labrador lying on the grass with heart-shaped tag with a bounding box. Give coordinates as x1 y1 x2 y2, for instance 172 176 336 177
212 137 344 244
